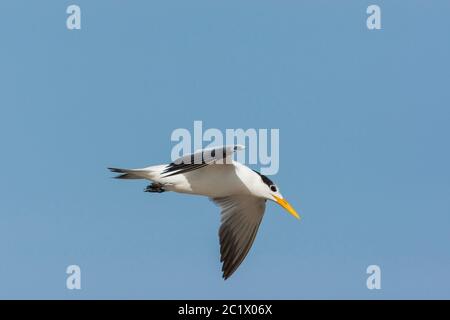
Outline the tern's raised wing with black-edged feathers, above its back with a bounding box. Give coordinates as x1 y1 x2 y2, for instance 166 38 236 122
161 145 244 177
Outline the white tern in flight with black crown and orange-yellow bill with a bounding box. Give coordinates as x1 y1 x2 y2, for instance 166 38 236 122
108 145 300 280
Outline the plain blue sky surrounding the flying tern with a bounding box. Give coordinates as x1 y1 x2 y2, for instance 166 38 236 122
0 0 450 299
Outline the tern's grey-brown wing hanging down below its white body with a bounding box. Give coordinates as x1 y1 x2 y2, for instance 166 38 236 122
212 195 266 279
